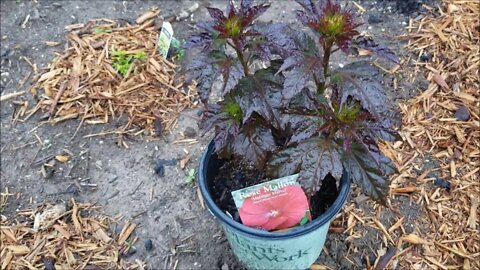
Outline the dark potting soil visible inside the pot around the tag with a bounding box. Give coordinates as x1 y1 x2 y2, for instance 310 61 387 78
211 160 338 227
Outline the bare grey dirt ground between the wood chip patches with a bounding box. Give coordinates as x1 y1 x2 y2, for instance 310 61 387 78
0 0 436 270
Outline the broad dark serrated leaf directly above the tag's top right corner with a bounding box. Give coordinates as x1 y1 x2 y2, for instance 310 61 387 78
267 137 343 194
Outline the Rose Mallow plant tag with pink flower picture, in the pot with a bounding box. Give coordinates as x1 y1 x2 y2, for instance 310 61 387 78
232 174 312 231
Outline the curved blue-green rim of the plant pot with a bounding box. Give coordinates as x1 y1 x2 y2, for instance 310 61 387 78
198 140 351 239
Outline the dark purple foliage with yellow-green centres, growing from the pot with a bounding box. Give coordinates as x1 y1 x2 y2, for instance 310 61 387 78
185 0 401 204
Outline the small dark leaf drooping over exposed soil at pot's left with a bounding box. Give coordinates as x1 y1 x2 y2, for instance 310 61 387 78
233 122 276 169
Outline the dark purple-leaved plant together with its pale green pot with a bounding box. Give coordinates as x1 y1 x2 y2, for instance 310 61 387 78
185 0 400 269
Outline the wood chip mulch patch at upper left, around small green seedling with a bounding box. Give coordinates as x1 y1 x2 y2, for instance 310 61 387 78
24 10 196 136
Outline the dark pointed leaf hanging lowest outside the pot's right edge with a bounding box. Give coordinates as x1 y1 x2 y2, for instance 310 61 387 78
342 143 395 205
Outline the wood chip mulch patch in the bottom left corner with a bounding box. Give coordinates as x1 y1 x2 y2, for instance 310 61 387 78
0 196 145 270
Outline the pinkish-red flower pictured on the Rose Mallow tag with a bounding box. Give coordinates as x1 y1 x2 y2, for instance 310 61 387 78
239 185 311 231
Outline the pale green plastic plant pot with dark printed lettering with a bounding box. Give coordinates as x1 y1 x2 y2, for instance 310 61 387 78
198 141 350 269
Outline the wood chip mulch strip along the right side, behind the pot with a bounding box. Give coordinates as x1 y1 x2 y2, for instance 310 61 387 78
318 0 480 270
